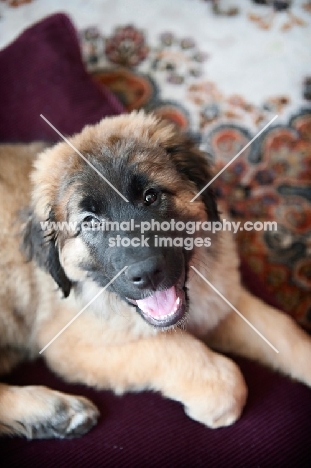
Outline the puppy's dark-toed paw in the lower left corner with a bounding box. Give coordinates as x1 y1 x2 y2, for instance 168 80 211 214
12 387 99 439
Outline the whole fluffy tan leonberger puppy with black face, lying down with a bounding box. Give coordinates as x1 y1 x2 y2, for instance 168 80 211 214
0 112 311 439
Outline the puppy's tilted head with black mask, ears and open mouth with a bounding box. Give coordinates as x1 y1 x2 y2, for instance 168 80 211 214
24 113 218 327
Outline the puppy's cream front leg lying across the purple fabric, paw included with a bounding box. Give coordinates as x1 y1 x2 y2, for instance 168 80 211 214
44 328 247 428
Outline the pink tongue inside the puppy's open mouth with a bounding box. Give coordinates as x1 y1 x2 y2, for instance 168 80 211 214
136 286 178 318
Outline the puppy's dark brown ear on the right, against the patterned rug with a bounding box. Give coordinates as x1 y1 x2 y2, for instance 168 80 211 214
165 135 219 221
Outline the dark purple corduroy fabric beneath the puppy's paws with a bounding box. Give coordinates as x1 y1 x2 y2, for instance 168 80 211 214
0 358 311 468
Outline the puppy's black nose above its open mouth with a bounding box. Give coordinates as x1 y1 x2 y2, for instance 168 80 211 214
125 255 165 289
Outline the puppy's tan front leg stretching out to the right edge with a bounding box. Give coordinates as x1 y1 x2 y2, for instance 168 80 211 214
207 289 311 386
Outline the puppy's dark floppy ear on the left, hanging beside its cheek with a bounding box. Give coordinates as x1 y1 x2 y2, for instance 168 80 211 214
21 208 72 297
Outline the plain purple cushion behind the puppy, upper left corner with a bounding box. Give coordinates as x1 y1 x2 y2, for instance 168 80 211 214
0 14 123 142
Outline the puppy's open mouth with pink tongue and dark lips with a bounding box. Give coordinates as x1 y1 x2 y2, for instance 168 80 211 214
130 286 186 328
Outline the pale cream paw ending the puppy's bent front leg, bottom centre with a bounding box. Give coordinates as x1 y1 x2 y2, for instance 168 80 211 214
185 363 247 429
